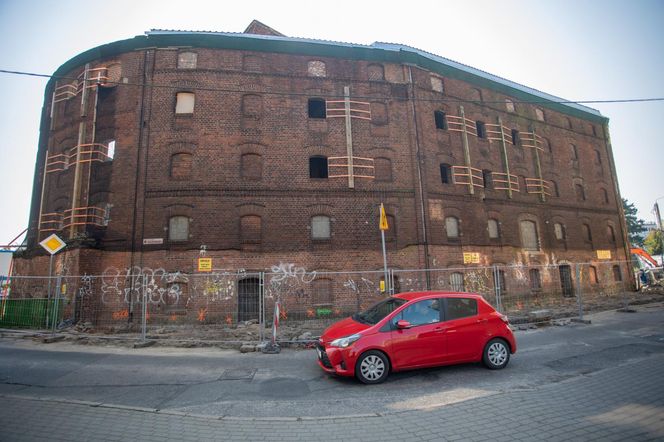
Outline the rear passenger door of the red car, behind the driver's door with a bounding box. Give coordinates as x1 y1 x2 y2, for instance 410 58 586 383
443 298 487 363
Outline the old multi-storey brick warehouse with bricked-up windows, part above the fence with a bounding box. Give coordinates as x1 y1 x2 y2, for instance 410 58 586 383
17 22 628 308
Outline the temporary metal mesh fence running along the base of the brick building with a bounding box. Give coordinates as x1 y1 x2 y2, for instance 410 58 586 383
0 262 661 345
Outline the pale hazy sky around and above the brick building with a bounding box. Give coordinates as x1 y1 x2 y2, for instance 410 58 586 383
0 0 664 245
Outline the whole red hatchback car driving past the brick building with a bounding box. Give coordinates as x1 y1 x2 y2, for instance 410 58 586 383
316 292 516 384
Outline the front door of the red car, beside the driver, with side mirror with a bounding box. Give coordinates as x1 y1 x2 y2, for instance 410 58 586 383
390 298 445 369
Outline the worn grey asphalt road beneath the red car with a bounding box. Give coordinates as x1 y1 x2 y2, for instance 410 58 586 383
0 303 664 420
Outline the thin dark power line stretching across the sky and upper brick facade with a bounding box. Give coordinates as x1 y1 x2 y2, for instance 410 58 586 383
0 69 664 104
